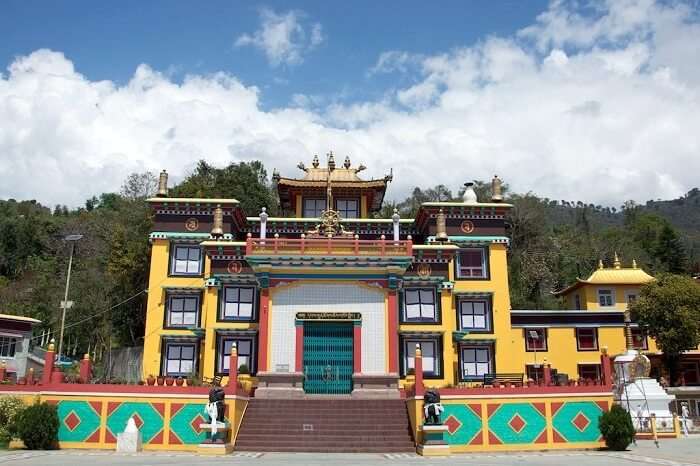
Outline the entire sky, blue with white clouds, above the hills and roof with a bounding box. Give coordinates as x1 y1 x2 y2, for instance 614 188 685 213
0 0 700 206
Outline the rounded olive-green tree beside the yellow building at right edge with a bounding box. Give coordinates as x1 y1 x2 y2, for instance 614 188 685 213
630 274 700 383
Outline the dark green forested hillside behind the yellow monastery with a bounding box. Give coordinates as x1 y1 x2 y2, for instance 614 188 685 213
0 162 700 374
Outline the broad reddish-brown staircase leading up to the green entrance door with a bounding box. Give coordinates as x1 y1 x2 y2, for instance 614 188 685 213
235 398 416 453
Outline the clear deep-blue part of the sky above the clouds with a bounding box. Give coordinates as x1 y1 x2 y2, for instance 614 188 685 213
0 0 547 108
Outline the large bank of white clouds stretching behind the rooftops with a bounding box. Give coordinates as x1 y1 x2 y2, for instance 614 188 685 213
0 1 700 205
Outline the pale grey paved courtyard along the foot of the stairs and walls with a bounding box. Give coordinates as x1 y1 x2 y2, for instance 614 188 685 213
0 436 700 466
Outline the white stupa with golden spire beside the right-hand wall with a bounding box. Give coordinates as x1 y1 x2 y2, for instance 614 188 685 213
615 314 676 428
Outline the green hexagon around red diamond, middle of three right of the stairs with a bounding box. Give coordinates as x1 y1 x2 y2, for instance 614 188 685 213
489 403 547 444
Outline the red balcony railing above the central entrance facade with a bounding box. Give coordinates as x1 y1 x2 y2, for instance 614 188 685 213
246 238 413 257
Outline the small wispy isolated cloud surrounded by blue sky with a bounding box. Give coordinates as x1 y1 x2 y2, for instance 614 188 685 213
235 8 324 66
